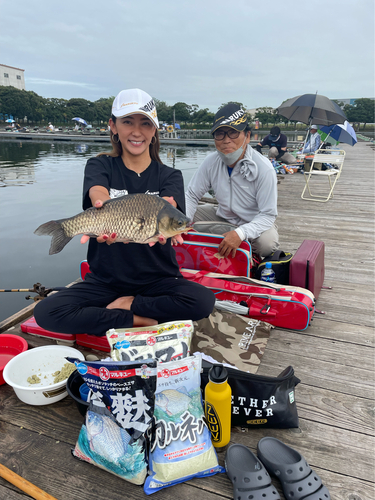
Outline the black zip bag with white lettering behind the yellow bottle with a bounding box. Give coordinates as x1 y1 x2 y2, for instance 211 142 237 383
201 360 300 429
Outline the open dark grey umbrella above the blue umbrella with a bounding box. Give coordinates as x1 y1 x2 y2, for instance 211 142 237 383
277 94 346 125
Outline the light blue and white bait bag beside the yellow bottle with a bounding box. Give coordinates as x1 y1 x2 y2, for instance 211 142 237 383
144 356 225 495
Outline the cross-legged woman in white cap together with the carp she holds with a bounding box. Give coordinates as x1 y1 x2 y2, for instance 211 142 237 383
34 89 215 336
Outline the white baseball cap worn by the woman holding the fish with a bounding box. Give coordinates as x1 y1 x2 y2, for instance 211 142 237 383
112 89 159 128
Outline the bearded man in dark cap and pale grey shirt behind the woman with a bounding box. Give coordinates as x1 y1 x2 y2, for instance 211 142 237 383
185 103 279 257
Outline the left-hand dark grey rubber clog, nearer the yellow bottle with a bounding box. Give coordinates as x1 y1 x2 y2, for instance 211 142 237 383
225 444 280 500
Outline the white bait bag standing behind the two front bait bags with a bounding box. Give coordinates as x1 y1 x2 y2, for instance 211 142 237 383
107 320 194 363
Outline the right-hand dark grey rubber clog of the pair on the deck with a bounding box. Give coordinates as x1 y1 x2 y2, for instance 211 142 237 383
257 437 331 500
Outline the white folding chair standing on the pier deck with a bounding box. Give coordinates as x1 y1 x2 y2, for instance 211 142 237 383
301 149 345 203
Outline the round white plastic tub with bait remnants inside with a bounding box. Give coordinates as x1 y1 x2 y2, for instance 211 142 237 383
3 346 85 406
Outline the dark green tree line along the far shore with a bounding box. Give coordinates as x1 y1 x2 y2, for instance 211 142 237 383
0 86 375 128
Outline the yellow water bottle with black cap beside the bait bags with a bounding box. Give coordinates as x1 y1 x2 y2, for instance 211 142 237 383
204 365 232 451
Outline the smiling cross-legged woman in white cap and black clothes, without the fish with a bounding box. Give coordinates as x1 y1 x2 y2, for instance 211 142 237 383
34 89 215 336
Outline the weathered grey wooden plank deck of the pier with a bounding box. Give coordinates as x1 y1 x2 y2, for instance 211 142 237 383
0 143 375 500
